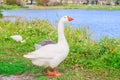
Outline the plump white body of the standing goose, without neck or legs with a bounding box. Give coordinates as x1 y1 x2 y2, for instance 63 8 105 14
24 44 69 68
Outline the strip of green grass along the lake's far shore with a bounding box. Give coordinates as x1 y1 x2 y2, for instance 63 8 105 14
0 4 120 10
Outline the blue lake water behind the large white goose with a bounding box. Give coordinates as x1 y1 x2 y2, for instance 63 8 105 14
3 10 120 38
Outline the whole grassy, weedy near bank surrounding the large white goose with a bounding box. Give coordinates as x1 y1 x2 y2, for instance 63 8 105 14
0 20 120 80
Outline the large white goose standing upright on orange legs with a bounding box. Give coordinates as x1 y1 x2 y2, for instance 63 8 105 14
24 16 73 76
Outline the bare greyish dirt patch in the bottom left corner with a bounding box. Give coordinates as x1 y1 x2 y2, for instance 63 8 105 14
0 75 34 80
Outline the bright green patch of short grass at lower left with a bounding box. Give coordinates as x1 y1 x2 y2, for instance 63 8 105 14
0 59 29 75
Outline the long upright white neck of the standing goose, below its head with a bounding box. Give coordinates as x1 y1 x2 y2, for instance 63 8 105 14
58 20 67 45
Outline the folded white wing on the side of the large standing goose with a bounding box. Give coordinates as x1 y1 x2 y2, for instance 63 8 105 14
24 44 64 59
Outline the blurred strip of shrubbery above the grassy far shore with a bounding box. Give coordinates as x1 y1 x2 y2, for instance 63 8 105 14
1 0 120 6
